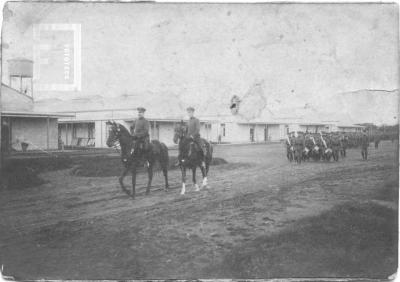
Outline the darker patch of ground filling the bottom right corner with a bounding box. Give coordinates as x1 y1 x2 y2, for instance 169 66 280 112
207 200 398 279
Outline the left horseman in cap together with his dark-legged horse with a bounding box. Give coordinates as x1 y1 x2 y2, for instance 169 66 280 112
107 108 169 198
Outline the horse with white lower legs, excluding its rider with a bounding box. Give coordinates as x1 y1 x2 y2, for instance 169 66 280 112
174 121 213 195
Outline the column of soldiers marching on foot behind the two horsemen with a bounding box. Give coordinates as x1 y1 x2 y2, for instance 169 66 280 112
285 130 381 163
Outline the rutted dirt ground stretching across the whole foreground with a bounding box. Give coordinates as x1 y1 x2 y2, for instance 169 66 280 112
0 142 398 279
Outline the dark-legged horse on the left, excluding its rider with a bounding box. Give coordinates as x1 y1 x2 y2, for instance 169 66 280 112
107 122 169 198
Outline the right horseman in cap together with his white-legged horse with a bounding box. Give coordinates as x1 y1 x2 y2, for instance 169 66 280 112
174 107 212 195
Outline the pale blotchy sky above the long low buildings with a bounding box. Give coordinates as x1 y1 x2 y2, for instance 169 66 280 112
2 2 399 123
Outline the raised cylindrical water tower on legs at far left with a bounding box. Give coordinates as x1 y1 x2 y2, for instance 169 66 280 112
8 58 33 98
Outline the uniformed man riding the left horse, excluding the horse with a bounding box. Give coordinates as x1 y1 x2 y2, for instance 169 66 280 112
131 107 150 167
